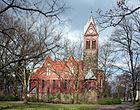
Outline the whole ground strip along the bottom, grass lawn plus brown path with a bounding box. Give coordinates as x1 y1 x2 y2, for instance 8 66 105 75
0 101 139 110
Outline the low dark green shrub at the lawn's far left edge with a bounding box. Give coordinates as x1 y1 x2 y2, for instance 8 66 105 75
0 95 19 101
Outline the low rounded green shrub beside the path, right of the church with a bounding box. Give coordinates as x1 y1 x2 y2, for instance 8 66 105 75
97 98 121 105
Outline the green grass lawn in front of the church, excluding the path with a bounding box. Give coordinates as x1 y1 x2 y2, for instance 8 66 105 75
0 101 97 110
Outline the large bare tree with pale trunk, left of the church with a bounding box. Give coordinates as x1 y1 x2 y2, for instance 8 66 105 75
0 3 64 102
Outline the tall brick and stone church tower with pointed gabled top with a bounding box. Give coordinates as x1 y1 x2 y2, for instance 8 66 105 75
83 16 98 75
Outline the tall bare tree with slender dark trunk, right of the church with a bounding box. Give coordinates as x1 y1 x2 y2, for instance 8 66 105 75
97 0 140 103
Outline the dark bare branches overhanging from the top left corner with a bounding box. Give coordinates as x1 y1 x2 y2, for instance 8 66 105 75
0 0 65 18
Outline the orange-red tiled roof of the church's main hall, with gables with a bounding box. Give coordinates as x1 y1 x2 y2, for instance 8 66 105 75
32 56 84 78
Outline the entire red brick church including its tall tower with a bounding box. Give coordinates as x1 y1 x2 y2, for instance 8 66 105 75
30 16 104 100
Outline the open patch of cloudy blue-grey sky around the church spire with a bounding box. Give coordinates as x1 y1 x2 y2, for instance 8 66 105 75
61 0 116 42
